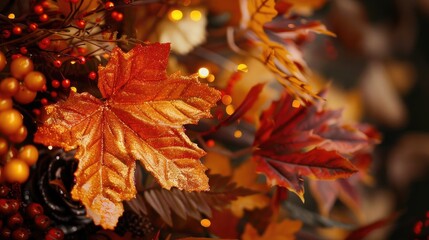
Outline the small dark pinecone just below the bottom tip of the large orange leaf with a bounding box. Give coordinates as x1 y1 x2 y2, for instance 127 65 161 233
115 211 155 238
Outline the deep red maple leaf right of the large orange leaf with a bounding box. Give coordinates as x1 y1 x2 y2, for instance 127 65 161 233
254 94 371 199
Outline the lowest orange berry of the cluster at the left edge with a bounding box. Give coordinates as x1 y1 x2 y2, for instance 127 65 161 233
2 158 30 183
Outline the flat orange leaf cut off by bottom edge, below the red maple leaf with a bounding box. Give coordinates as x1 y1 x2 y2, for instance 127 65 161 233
241 220 302 240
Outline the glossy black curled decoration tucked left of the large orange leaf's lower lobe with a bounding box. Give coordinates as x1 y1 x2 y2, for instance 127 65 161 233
24 150 92 236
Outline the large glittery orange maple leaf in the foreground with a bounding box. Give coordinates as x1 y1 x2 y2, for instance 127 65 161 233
34 44 220 229
